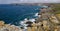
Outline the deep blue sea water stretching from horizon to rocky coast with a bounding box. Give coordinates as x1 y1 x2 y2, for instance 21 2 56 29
0 4 41 25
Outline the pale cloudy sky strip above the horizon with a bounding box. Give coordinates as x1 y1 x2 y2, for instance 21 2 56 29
0 0 60 4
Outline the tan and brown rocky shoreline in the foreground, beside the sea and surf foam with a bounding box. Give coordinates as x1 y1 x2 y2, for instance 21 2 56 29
0 6 60 31
